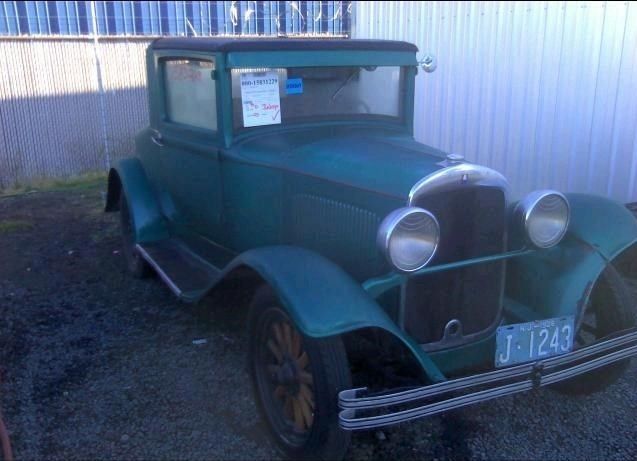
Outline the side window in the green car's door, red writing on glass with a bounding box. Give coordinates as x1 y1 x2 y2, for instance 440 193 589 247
161 58 217 131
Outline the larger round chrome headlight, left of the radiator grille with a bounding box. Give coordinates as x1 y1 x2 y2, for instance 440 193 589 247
378 207 440 272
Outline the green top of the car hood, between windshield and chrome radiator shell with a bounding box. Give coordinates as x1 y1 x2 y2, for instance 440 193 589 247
231 126 445 198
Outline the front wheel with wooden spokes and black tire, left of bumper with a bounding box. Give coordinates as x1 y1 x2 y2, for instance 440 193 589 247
248 286 351 460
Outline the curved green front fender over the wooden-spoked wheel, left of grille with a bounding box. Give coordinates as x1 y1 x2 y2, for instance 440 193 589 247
220 246 445 381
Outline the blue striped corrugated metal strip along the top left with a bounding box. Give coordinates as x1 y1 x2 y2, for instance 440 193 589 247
0 0 351 35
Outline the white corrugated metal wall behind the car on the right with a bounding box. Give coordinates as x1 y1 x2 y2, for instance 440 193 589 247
352 2 637 202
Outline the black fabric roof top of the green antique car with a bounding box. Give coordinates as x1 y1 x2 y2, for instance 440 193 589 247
151 37 418 52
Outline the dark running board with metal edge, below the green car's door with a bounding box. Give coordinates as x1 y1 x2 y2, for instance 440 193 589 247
135 239 220 302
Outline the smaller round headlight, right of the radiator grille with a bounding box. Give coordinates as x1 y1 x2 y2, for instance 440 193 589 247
518 190 570 248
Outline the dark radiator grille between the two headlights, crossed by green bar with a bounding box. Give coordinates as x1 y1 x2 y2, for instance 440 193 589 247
404 187 506 348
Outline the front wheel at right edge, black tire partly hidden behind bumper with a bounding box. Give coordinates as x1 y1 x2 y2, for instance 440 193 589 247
553 264 635 395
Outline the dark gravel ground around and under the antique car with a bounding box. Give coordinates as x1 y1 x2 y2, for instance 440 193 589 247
0 187 637 459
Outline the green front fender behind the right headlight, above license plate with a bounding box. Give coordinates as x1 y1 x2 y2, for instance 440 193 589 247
506 194 637 318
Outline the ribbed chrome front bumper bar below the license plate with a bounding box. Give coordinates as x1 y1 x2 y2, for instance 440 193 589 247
338 329 637 431
